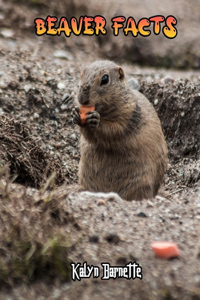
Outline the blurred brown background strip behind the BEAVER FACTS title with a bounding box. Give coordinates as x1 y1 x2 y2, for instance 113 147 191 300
0 0 200 69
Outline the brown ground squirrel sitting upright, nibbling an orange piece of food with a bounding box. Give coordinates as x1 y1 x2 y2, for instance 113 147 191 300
72 60 168 200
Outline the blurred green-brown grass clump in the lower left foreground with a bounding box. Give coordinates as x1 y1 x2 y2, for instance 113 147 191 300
0 179 73 286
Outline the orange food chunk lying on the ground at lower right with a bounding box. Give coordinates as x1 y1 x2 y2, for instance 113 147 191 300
151 241 180 258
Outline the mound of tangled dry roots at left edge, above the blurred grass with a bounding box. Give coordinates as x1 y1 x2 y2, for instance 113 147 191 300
0 116 64 188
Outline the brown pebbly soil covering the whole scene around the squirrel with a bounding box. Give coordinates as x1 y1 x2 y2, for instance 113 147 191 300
0 1 200 300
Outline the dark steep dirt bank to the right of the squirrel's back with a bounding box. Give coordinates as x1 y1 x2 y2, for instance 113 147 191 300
141 78 200 160
